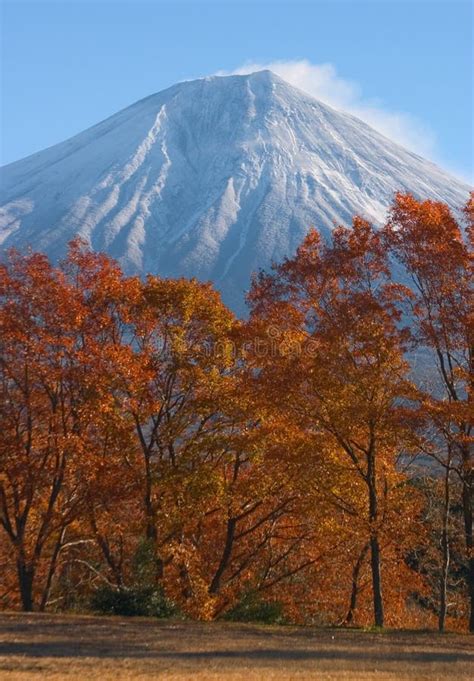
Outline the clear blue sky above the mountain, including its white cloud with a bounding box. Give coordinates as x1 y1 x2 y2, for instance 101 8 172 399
1 0 473 179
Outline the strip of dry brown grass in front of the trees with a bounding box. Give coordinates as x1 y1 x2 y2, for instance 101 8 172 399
0 613 474 681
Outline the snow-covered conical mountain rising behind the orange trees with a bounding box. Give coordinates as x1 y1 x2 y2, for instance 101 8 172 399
0 71 469 312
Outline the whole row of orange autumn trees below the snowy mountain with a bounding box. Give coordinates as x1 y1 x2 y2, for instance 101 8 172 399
0 194 474 631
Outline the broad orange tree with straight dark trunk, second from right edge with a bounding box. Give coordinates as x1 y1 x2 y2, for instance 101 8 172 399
246 218 420 626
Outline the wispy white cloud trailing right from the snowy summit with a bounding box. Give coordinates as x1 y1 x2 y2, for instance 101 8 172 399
217 59 436 158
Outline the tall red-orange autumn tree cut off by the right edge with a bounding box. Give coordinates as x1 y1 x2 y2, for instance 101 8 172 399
384 194 474 631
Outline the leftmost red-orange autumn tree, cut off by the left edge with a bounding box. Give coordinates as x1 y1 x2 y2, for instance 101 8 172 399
0 248 112 610
